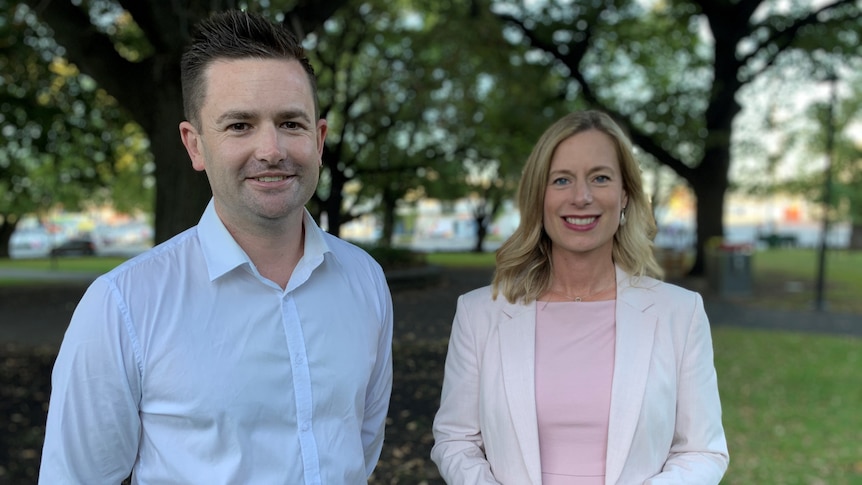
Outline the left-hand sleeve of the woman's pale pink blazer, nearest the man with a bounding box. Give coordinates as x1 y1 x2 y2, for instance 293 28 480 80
431 295 506 485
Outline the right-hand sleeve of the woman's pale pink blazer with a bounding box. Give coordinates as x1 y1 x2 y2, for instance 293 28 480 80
645 294 730 485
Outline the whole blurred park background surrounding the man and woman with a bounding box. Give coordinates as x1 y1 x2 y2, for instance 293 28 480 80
0 0 862 485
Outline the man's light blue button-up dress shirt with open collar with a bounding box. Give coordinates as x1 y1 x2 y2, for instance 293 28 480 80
39 202 392 485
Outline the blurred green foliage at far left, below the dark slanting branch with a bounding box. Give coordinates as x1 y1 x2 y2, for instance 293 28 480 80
0 2 150 257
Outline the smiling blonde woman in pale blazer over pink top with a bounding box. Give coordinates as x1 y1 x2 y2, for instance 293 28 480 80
431 111 729 485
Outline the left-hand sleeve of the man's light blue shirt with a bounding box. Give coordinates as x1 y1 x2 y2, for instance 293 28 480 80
39 278 141 485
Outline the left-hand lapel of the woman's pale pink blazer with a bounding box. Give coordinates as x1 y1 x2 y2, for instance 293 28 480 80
498 302 542 484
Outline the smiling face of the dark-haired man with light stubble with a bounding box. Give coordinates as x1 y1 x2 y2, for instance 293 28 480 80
180 59 327 231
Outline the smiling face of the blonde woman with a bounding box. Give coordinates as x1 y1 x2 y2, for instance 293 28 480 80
542 130 628 257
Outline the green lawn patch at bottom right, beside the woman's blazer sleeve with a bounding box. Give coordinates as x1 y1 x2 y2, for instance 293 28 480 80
713 327 862 485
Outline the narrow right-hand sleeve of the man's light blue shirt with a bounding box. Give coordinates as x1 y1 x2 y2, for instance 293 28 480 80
362 271 393 476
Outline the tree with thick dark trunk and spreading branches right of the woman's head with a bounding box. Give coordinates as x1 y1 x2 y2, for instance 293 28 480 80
490 0 862 274
